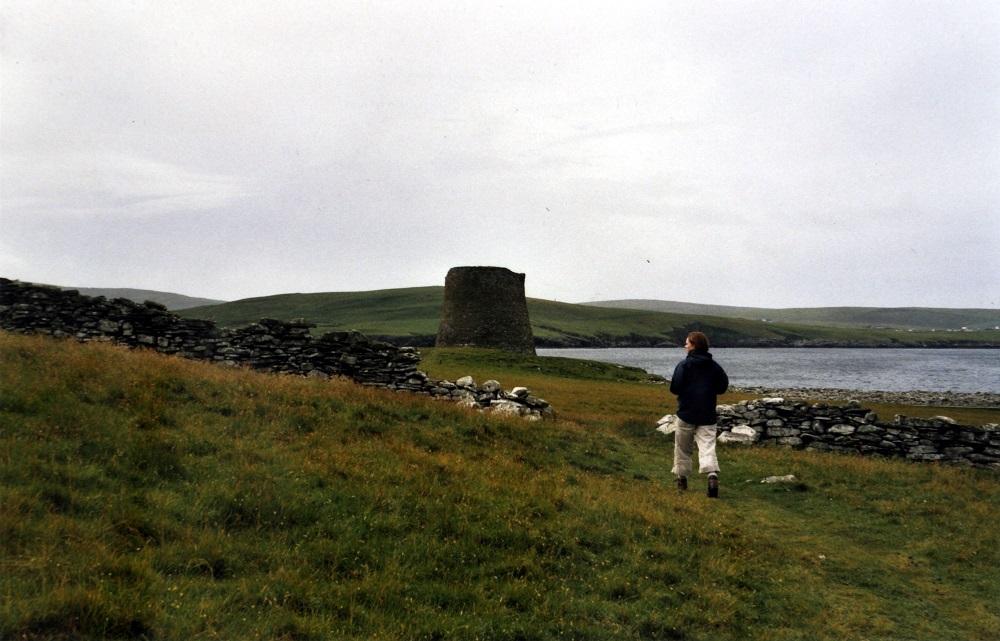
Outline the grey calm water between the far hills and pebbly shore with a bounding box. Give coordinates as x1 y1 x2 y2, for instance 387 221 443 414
538 347 1000 393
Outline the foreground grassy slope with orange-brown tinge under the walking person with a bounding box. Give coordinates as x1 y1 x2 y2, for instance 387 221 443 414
0 333 1000 641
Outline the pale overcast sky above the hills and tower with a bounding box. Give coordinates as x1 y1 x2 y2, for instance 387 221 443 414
0 0 1000 308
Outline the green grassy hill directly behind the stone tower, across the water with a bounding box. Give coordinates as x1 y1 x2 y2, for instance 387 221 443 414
181 287 1000 347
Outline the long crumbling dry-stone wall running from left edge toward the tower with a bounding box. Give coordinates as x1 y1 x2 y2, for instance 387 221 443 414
0 278 552 419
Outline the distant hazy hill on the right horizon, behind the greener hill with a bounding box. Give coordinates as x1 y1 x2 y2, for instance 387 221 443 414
583 299 1000 330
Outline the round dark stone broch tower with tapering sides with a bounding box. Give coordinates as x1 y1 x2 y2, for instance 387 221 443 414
436 267 535 354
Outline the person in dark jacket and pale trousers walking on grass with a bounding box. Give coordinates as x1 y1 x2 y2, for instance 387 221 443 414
670 332 729 498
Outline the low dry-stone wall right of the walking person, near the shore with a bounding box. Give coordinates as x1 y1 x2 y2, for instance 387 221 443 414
704 398 1000 469
